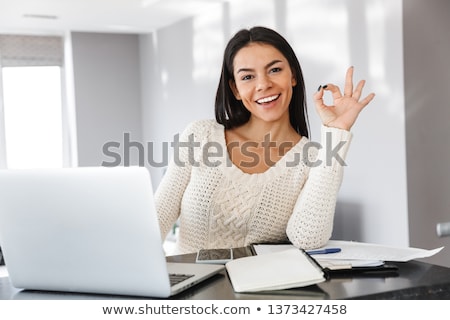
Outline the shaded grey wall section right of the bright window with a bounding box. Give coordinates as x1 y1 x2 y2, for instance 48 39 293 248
71 32 142 166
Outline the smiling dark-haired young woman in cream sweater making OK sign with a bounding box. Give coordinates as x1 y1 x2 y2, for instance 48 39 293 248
155 27 374 253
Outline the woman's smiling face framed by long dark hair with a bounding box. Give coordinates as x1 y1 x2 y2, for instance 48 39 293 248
230 42 297 126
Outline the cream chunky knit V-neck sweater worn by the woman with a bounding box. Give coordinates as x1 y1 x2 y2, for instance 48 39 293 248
155 120 351 253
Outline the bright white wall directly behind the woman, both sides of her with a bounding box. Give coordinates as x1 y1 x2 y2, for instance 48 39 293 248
140 0 409 245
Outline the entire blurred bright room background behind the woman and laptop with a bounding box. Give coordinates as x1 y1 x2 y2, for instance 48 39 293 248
0 0 450 267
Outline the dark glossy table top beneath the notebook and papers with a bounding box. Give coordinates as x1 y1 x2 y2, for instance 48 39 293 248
164 254 450 300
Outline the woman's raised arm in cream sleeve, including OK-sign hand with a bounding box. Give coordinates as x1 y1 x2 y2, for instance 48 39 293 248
286 67 375 249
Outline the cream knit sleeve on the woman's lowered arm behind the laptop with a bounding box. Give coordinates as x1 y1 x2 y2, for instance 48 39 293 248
155 123 195 240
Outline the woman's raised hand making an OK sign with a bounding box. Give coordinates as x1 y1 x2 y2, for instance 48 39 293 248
314 67 375 131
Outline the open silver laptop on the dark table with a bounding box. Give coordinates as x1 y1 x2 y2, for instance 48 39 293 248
0 167 224 297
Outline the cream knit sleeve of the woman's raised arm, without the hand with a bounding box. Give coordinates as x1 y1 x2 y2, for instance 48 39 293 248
286 126 352 249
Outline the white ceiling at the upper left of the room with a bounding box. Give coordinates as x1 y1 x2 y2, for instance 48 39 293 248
0 0 226 33
